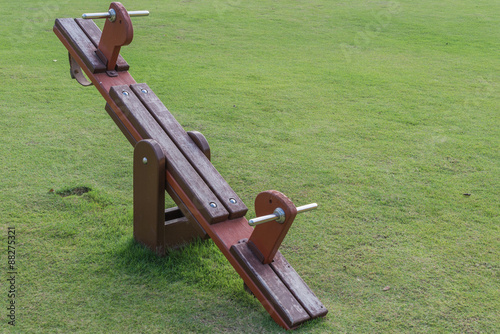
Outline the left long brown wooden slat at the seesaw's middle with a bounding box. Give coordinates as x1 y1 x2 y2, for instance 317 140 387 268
109 85 229 224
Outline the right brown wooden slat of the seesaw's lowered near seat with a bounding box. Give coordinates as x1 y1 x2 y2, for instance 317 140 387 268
270 252 328 319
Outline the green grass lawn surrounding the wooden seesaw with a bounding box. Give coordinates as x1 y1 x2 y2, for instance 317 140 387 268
0 0 500 333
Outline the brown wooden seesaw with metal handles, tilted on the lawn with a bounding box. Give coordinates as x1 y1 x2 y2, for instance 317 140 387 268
54 2 328 329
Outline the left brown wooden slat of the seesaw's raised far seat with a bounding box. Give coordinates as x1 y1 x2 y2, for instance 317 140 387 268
55 19 106 73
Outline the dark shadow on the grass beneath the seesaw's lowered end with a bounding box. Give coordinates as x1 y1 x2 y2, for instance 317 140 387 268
114 239 326 333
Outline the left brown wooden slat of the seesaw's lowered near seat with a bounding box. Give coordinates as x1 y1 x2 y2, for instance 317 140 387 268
230 243 310 328
